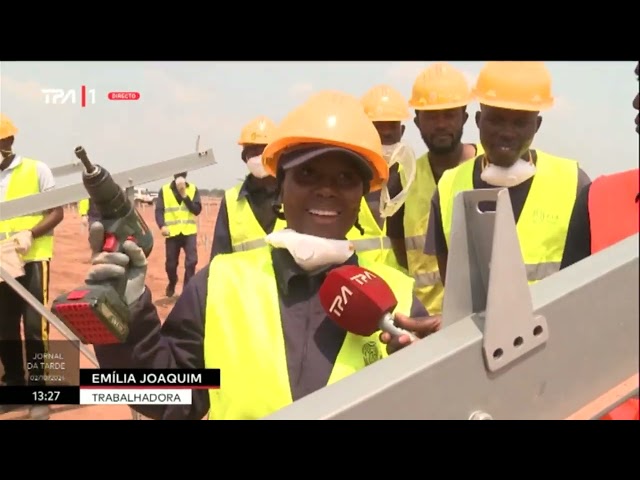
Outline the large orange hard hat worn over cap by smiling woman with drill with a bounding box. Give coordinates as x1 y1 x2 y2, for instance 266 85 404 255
262 90 389 191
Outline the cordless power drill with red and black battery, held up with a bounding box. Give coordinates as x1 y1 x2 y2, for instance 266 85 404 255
52 147 153 345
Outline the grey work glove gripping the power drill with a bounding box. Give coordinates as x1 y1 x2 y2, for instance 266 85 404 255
85 222 147 305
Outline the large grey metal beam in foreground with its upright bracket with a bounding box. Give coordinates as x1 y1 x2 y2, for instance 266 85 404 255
265 188 640 420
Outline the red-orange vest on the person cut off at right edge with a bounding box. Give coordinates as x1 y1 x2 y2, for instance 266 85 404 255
588 168 640 253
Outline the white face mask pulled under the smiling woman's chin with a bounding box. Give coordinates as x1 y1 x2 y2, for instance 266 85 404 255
265 228 355 272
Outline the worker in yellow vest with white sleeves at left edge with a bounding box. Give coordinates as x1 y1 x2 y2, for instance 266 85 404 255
0 114 64 420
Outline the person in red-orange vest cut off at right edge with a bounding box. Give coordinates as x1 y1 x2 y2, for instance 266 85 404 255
560 64 640 420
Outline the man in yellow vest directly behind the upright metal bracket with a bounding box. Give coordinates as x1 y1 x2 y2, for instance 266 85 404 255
425 62 589 283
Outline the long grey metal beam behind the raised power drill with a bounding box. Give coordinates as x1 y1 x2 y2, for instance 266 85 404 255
0 149 216 220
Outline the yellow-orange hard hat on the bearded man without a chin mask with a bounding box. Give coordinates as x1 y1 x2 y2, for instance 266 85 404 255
409 62 473 110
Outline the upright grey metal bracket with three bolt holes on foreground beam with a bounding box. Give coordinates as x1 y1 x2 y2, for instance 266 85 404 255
443 188 549 372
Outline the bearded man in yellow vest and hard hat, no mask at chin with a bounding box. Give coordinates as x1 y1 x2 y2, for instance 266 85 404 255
387 63 483 314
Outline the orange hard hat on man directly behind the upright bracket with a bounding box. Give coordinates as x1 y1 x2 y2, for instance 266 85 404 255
473 62 553 112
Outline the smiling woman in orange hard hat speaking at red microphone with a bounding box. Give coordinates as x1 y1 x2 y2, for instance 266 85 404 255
87 91 438 419
